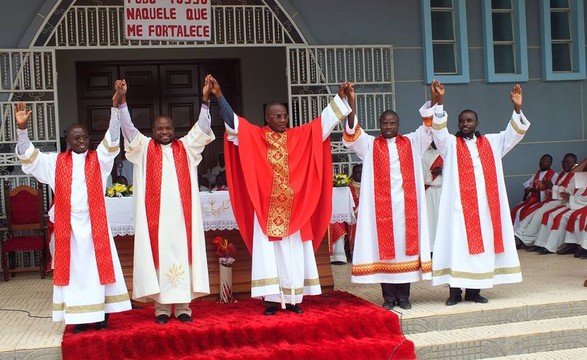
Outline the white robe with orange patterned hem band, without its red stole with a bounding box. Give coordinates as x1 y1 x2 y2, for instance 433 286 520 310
344 109 432 284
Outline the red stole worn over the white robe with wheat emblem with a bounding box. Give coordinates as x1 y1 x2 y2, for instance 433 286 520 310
145 139 192 268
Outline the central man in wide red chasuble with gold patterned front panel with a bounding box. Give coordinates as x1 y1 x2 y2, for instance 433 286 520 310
208 76 351 315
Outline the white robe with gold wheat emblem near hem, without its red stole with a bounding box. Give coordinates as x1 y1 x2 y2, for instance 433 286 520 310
121 108 214 304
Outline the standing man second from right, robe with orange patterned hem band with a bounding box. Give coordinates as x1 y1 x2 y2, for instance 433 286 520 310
343 83 436 310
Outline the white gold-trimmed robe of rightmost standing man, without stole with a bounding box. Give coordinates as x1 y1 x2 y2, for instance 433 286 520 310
432 107 530 289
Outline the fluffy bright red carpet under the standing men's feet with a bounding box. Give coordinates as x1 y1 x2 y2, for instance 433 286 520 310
62 291 416 360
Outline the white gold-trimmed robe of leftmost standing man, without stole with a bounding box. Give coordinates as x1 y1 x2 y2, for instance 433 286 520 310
17 109 131 324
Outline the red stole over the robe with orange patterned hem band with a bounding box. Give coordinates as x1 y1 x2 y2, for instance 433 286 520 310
373 134 420 260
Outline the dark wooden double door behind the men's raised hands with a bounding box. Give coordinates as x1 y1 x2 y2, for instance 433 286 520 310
77 59 242 173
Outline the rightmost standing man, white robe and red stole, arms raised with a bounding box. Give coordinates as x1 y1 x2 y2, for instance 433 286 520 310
432 81 530 306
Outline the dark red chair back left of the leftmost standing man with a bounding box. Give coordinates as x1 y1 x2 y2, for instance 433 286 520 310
4 181 45 231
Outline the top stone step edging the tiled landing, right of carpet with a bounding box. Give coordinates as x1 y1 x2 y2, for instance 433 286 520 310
401 300 587 334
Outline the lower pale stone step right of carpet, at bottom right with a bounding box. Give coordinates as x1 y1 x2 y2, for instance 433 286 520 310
406 315 587 360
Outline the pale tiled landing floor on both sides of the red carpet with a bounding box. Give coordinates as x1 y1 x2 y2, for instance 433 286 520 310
0 250 587 360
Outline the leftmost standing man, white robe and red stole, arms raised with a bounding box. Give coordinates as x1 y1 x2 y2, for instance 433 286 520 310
15 83 131 333
